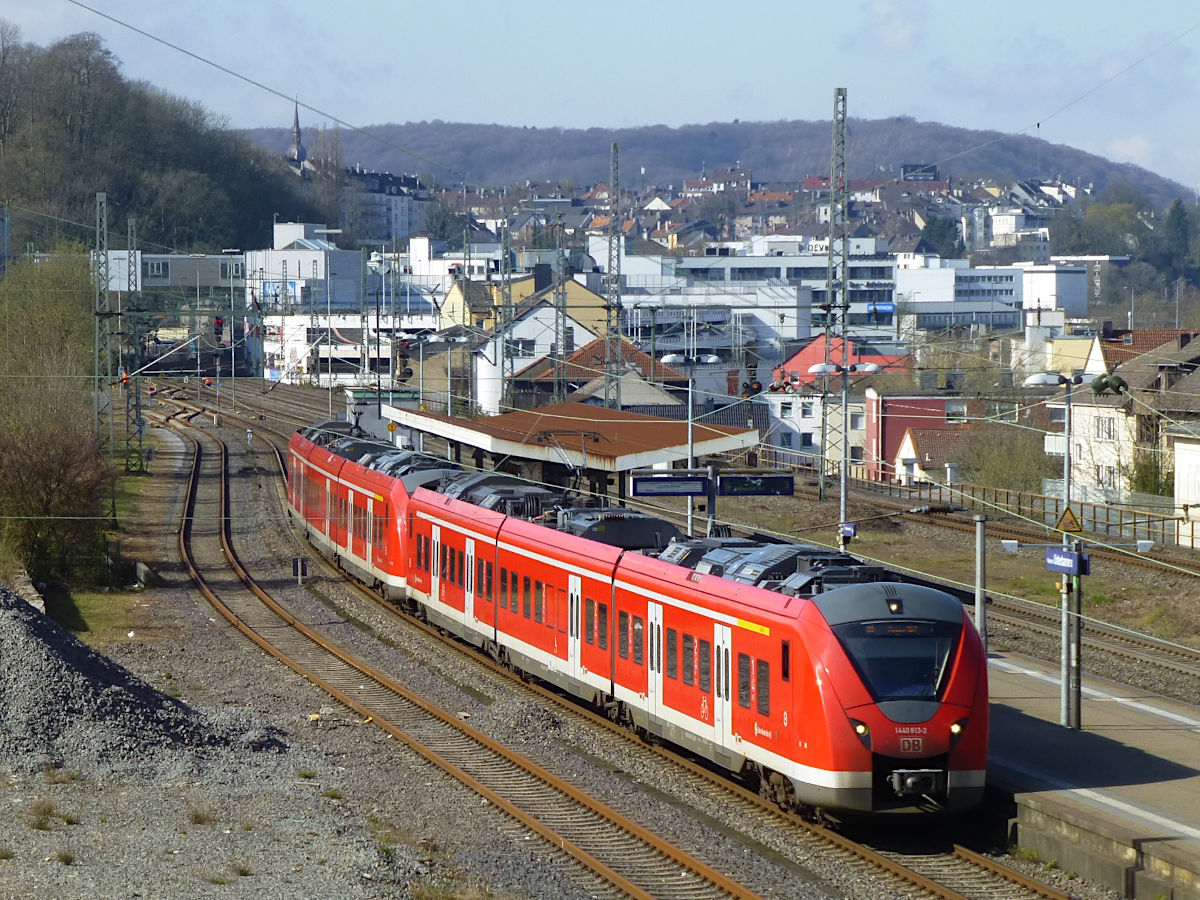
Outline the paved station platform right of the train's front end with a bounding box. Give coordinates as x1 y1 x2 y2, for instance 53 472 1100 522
988 653 1200 900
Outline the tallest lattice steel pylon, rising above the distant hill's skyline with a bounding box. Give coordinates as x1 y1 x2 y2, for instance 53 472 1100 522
817 88 850 500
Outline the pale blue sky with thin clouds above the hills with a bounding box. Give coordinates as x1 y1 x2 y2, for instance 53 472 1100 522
9 0 1200 188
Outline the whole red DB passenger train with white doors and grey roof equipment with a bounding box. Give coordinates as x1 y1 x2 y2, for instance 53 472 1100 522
288 422 988 814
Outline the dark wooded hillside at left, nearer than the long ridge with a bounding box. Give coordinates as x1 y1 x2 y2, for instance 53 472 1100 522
0 19 316 251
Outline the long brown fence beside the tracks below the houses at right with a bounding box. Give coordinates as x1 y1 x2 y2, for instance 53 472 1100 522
757 444 1200 550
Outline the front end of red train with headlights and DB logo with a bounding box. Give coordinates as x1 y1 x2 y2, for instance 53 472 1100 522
811 582 988 814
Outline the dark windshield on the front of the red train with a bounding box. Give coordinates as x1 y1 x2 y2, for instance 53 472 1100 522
833 619 962 703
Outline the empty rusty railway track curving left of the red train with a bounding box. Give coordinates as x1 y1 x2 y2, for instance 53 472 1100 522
165 408 755 898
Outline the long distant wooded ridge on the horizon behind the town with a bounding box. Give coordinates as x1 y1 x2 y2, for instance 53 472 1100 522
245 113 1189 209
